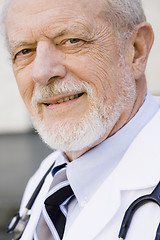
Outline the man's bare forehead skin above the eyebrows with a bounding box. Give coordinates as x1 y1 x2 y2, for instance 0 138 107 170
7 0 104 33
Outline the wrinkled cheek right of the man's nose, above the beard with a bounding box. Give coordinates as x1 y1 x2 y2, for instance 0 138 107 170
66 51 118 100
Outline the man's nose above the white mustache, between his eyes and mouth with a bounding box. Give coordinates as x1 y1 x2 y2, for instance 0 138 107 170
32 41 66 85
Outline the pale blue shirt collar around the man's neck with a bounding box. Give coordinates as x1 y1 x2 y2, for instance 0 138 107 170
56 92 158 205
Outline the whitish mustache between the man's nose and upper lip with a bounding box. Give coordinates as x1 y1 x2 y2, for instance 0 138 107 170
32 80 92 105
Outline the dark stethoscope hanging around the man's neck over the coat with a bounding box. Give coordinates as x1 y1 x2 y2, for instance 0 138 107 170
7 162 160 240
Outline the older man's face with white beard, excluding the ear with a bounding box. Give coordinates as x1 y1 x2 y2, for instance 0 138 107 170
7 0 136 156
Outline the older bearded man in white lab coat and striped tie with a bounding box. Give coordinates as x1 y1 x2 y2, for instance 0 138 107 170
6 0 160 240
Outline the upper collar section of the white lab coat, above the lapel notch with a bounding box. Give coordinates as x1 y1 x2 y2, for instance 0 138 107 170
113 111 160 190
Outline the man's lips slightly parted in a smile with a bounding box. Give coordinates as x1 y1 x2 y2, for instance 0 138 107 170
39 92 85 108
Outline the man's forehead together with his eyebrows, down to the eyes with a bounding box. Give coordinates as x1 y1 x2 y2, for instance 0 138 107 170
6 0 109 47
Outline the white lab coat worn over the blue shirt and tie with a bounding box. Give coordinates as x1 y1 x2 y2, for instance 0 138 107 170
21 111 160 240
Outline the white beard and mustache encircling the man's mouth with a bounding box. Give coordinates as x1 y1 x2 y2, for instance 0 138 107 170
32 68 136 152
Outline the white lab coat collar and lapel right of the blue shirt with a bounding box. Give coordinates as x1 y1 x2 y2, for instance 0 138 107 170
63 111 160 240
